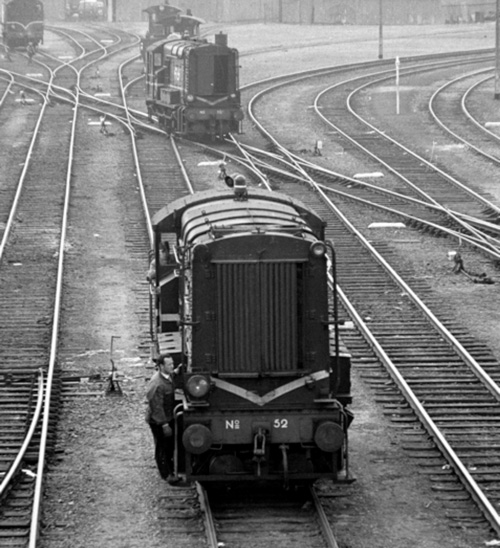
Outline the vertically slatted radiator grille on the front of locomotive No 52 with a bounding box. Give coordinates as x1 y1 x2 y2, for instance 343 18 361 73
217 263 300 373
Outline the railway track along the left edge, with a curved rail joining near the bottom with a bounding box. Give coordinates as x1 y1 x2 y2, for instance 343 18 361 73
0 25 146 547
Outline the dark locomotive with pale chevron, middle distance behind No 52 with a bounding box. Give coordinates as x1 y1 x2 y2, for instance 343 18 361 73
146 33 243 138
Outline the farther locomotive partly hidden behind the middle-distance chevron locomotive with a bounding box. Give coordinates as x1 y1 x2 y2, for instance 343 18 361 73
141 4 204 59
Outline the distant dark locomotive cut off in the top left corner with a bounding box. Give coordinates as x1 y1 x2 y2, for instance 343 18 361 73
2 0 44 48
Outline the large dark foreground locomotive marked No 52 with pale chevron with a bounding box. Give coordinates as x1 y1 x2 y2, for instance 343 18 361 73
147 185 352 483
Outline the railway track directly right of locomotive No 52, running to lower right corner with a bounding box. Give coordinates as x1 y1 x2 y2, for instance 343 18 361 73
123 45 499 529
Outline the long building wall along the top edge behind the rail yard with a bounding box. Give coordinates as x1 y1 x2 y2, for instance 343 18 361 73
44 0 496 25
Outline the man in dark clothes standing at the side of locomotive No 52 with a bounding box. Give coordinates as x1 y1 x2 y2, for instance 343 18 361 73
146 354 179 484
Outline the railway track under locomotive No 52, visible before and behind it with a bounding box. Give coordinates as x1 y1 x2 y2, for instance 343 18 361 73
121 66 348 548
